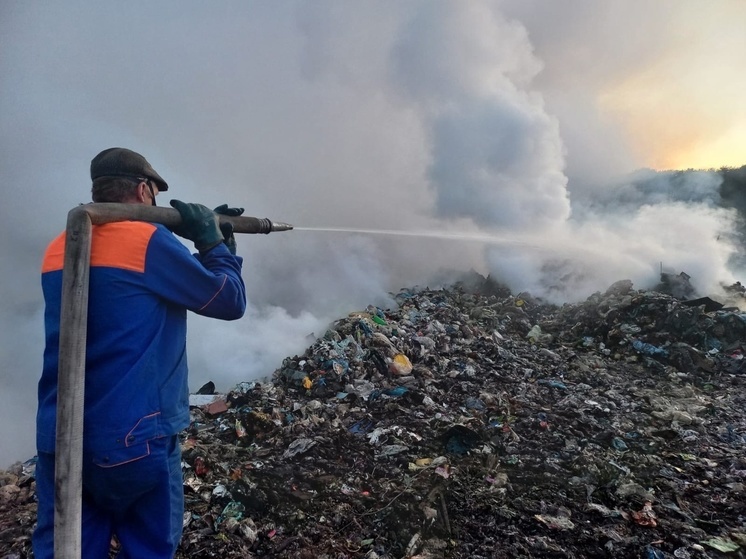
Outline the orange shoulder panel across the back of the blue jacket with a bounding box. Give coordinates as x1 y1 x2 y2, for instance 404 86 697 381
41 221 156 273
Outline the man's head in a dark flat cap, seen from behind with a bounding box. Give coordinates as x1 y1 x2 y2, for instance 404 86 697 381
91 148 168 205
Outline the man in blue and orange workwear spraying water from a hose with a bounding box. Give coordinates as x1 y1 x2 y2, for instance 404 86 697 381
33 148 246 559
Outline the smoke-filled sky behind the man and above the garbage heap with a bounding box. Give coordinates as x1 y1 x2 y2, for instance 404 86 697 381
0 0 746 467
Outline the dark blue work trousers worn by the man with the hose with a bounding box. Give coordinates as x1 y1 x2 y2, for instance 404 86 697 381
32 435 184 559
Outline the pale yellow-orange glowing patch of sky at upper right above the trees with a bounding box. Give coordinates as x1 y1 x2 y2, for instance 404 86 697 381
599 2 746 170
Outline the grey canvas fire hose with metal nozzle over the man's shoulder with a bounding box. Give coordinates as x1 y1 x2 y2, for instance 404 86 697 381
54 204 293 559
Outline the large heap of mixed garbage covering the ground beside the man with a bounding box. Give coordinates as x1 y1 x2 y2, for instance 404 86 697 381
0 281 746 559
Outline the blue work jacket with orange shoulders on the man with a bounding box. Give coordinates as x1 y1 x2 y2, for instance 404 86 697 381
36 221 246 466
